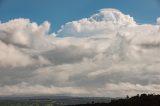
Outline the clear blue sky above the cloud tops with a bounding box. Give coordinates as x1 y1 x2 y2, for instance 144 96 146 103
0 0 160 31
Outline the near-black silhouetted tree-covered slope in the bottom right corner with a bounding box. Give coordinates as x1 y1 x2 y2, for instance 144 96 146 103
69 94 160 106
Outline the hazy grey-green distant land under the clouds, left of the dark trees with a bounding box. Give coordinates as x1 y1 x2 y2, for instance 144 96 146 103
0 95 111 106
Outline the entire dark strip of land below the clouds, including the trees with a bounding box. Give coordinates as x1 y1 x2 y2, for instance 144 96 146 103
0 94 160 106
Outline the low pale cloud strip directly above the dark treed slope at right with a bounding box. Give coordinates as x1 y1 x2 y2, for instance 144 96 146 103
99 83 160 97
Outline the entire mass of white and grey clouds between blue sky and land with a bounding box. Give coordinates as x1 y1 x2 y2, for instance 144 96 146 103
0 9 160 97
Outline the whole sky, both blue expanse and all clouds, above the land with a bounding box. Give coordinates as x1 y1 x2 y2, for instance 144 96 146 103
0 0 160 97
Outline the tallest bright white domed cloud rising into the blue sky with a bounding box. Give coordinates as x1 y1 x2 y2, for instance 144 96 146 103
58 9 136 37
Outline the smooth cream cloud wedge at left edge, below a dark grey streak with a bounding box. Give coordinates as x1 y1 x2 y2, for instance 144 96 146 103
0 42 33 67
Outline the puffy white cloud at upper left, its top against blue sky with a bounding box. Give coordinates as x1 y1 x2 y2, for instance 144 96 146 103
0 18 50 48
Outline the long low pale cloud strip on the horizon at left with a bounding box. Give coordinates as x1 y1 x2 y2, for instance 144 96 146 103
0 82 87 96
